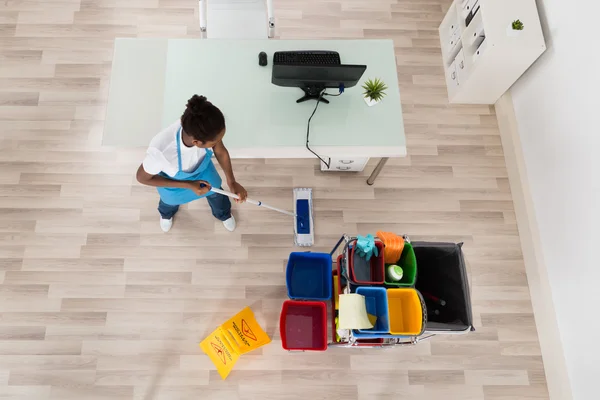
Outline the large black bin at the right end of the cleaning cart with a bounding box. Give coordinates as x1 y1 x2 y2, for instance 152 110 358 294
411 242 473 334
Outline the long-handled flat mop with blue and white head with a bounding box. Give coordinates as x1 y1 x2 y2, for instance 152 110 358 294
210 188 315 247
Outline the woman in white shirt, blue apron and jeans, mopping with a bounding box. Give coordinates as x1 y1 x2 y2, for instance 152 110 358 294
136 95 248 232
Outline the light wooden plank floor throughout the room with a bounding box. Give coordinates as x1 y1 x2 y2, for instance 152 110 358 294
0 0 548 400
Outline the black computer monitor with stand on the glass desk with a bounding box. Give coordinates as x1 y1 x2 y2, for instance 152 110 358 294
271 64 367 103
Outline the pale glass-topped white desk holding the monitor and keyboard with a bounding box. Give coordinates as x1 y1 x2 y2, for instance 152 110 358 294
103 39 406 182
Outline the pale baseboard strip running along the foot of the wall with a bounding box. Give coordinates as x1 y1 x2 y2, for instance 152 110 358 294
496 91 573 400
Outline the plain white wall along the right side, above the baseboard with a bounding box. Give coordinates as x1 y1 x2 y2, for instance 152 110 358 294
511 0 600 400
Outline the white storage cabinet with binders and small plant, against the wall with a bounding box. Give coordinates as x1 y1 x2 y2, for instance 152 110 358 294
439 0 546 104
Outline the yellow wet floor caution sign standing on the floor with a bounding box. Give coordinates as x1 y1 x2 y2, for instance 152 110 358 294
200 307 271 379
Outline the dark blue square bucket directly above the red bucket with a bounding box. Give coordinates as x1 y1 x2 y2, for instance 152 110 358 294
285 252 333 300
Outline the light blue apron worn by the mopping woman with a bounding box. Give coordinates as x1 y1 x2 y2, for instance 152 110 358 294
157 128 222 206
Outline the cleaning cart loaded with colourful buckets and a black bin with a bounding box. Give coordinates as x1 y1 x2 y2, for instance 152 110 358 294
280 232 474 351
